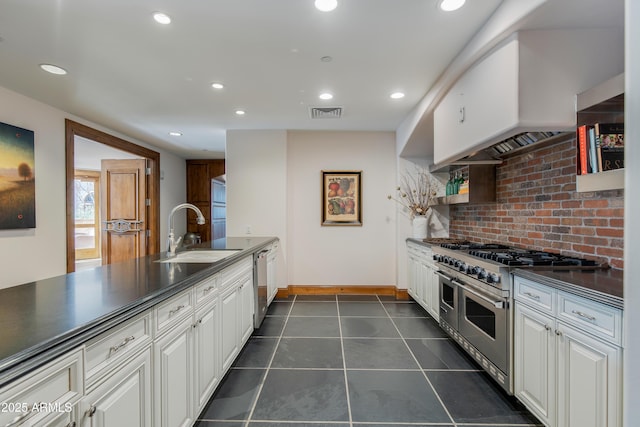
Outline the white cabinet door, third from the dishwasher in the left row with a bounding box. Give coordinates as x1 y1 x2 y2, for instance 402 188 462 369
193 298 221 413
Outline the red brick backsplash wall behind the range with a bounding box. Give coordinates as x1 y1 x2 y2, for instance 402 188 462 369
449 139 624 269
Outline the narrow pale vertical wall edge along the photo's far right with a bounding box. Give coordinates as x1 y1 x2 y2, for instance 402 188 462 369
623 0 640 427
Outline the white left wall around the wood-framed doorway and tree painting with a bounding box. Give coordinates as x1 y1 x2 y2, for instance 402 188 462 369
0 87 186 288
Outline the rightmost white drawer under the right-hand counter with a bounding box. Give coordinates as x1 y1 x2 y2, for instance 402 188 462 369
558 291 622 345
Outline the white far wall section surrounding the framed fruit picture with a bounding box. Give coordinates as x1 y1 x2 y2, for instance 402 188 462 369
286 131 396 286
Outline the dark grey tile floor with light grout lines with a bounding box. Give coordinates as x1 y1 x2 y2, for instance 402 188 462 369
196 295 539 427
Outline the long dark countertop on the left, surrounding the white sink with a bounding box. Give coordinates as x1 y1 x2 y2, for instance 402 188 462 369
0 237 276 386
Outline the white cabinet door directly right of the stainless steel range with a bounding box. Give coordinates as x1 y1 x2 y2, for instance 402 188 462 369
514 303 556 425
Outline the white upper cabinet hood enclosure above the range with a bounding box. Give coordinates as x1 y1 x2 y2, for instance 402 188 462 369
434 29 624 164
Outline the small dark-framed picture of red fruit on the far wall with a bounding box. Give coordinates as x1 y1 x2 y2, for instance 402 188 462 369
321 171 362 226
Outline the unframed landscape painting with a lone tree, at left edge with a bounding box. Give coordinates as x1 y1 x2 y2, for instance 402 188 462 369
0 123 36 230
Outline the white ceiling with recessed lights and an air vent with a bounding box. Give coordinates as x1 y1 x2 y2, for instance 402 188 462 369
0 0 623 158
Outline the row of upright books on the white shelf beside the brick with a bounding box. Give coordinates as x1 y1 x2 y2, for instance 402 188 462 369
576 123 624 175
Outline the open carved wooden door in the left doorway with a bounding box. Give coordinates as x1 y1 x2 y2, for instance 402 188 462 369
100 159 148 265
